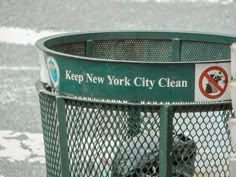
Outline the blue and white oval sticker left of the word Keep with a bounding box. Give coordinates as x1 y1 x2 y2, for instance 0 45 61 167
47 57 60 87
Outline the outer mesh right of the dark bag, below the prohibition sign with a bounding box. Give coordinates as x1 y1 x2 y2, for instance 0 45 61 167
173 105 232 177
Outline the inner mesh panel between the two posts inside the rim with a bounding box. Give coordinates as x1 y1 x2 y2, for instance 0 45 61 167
93 40 172 62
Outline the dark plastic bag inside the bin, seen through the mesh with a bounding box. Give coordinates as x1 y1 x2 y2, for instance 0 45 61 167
112 134 197 177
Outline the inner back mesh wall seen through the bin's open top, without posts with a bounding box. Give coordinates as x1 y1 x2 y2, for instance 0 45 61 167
50 39 230 62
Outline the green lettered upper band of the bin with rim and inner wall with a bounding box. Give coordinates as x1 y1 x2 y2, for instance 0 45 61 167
36 32 236 102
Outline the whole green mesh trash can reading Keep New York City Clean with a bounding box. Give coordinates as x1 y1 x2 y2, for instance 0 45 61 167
36 32 236 177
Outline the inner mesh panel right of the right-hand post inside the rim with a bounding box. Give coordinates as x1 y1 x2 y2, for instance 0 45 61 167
180 41 230 61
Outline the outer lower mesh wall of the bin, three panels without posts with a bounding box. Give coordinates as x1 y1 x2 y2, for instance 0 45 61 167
37 90 232 177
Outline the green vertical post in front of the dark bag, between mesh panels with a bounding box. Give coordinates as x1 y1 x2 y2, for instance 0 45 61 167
159 105 173 177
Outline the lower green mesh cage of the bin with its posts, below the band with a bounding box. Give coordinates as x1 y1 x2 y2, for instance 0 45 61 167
36 82 233 177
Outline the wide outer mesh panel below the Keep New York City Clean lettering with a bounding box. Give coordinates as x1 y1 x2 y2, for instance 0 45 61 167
66 101 159 177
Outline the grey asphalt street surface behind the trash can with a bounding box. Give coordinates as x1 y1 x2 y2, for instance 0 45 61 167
0 0 236 177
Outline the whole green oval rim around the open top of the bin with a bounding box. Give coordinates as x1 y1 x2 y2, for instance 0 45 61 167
35 31 236 64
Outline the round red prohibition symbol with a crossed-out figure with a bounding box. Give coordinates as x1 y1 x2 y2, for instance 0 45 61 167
198 66 228 99
